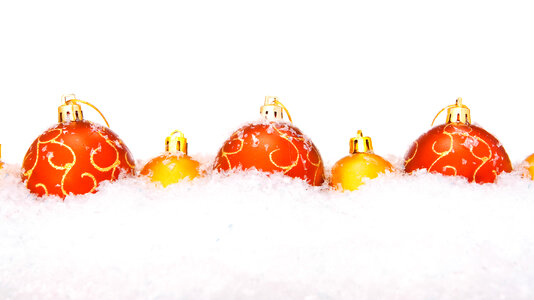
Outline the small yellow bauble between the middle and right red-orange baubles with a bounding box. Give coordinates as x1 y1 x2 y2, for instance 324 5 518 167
330 130 393 191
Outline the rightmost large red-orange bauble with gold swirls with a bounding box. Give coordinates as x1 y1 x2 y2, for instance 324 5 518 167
405 98 512 183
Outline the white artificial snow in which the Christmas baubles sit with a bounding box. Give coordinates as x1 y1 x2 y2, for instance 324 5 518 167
0 159 534 300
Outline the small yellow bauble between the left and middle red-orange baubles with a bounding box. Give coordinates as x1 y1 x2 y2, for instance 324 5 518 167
141 130 200 187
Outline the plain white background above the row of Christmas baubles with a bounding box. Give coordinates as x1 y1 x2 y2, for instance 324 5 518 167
0 0 534 165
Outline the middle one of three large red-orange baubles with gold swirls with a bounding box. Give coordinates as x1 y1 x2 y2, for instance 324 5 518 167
214 96 324 186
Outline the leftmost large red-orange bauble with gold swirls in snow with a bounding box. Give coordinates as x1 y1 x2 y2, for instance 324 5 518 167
22 95 135 198
